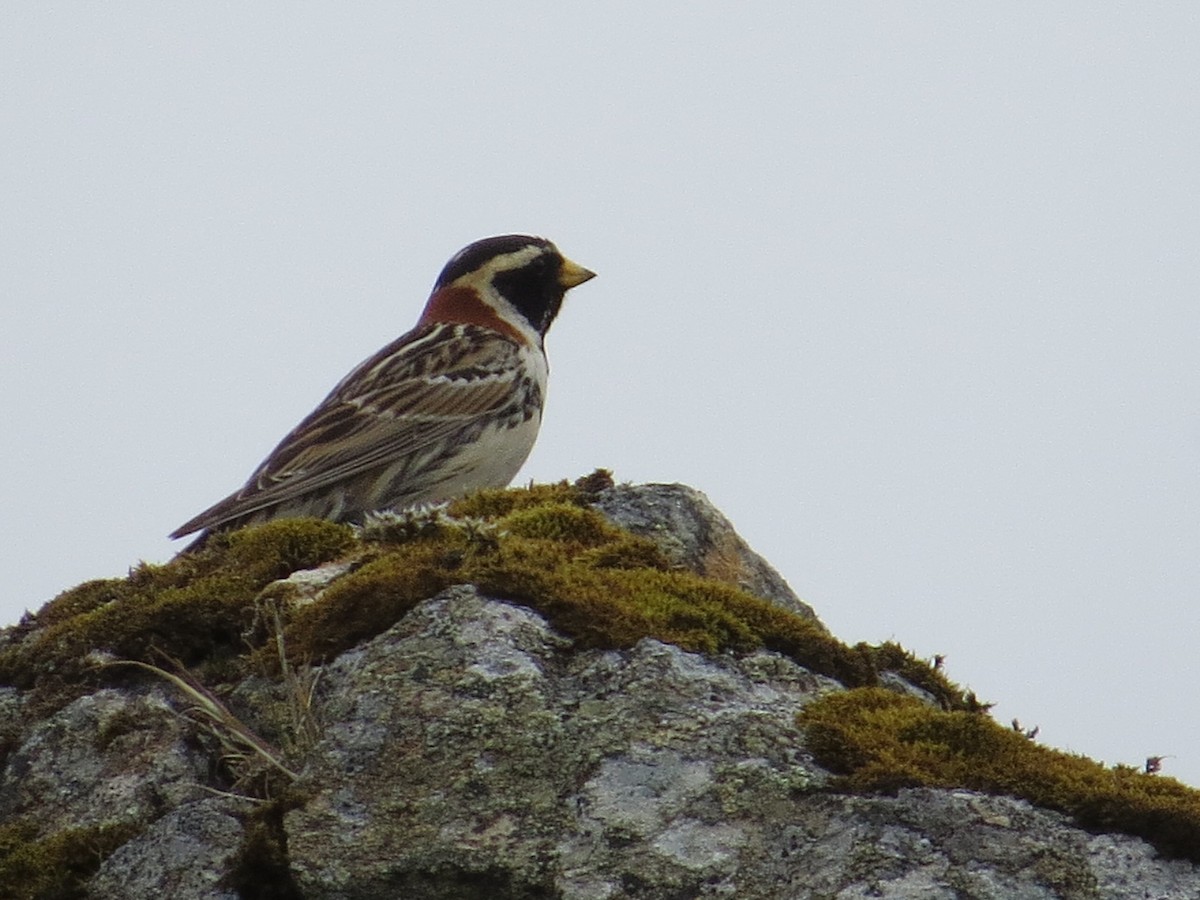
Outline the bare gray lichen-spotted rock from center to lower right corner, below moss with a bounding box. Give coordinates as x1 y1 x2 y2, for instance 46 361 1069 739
278 587 1200 900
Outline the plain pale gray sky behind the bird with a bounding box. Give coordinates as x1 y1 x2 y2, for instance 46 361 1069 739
0 8 1200 785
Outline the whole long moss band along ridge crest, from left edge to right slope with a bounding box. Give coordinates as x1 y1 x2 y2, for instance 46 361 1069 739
0 480 965 734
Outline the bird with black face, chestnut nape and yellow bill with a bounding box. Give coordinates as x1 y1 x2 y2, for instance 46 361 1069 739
170 234 595 551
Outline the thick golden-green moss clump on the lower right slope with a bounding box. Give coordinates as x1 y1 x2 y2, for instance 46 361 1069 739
799 688 1200 862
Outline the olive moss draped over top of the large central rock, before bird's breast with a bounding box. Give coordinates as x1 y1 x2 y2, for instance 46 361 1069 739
276 501 876 684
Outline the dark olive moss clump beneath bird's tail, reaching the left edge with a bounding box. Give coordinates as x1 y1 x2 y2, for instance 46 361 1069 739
0 520 355 707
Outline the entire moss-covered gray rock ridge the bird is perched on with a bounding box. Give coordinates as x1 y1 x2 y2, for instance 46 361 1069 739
0 473 1200 900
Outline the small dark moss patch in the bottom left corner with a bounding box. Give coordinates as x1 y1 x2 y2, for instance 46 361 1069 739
0 820 139 900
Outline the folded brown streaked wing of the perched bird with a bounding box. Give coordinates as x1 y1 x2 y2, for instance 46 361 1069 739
175 324 526 535
